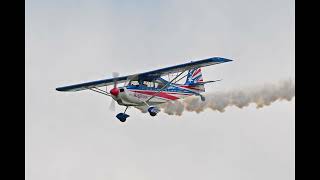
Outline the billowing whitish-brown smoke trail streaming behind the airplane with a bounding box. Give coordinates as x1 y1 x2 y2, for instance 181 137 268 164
160 79 295 116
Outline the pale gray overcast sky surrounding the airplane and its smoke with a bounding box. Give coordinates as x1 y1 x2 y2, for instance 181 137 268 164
25 0 295 180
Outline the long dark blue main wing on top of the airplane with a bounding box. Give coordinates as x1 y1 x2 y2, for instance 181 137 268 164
56 57 232 91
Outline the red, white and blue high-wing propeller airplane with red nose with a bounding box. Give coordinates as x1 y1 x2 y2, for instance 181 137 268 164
56 57 232 122
